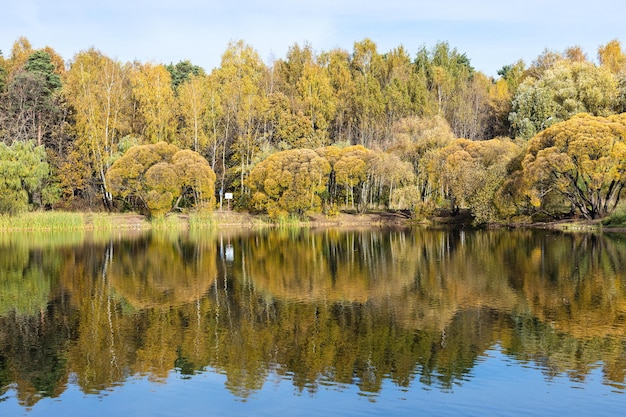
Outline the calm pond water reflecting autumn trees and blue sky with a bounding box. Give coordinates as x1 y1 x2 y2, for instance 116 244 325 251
0 229 626 417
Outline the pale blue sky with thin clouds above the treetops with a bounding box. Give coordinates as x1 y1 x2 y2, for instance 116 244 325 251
0 0 626 77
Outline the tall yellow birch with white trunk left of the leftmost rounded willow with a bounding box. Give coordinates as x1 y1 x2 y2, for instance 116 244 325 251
60 49 130 206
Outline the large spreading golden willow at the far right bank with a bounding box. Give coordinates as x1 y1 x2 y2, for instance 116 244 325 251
521 114 626 219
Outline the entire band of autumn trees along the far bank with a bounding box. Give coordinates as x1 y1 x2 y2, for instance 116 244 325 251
0 37 626 223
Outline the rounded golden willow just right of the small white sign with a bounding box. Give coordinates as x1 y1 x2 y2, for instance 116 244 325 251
247 149 330 218
